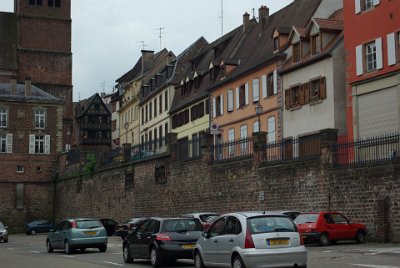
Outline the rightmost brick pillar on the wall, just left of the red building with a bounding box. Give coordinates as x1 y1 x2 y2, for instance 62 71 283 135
319 128 338 166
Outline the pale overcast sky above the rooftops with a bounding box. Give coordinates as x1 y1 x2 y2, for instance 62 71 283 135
0 0 292 101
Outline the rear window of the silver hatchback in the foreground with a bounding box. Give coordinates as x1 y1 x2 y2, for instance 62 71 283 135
247 216 296 234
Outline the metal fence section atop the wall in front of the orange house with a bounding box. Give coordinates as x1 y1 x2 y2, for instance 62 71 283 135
211 138 253 161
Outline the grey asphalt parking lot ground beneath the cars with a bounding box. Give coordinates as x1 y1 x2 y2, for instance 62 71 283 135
0 234 400 268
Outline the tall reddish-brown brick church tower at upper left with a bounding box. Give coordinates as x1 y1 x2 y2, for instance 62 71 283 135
14 0 72 145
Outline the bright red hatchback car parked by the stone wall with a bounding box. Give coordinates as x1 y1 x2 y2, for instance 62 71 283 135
294 212 367 246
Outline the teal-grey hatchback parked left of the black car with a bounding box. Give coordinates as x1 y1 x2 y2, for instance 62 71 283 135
46 218 107 254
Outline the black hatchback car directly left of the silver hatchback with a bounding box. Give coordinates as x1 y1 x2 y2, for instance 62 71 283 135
122 218 203 267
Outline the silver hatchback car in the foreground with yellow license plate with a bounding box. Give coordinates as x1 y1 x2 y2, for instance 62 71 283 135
194 212 307 268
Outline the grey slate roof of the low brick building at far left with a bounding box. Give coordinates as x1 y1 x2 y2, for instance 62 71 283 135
0 83 62 103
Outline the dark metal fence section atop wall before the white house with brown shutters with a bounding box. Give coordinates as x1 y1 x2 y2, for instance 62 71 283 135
262 134 321 164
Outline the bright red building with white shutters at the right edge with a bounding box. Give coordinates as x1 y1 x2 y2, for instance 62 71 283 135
343 0 400 138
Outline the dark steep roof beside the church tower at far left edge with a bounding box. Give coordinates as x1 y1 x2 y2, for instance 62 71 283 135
0 12 17 70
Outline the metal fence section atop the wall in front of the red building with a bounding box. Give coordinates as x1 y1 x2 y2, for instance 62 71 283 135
333 133 400 166
